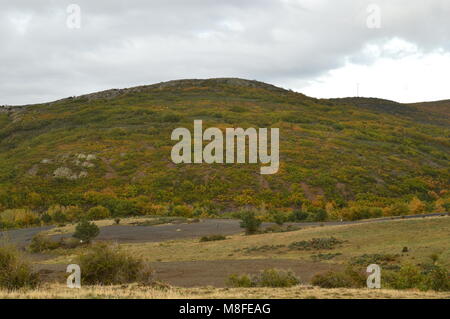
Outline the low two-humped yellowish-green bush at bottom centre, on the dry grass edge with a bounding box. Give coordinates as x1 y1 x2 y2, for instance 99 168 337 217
227 269 300 288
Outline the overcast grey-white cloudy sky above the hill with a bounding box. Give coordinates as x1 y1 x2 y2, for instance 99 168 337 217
0 0 450 105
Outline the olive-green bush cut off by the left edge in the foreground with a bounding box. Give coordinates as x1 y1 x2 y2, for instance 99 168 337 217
0 246 40 290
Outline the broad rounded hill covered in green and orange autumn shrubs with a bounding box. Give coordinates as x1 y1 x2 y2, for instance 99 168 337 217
0 78 450 225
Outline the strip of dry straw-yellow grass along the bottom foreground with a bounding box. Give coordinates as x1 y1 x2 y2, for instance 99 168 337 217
0 284 450 299
